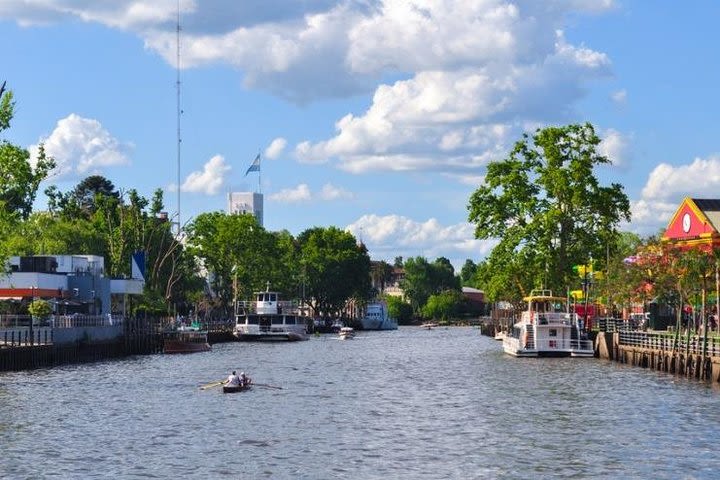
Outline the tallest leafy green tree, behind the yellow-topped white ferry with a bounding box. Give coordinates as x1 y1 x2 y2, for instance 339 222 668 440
468 123 630 296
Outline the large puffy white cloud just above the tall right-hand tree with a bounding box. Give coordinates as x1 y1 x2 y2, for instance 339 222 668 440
295 26 610 173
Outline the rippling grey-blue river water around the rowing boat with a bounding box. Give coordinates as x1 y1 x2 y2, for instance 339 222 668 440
0 327 720 479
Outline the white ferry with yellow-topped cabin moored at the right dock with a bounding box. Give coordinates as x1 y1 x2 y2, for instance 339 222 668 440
503 290 594 357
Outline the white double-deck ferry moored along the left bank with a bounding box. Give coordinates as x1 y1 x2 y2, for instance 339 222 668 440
233 282 308 341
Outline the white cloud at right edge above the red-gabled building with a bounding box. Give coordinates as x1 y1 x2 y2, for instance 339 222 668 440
642 156 720 200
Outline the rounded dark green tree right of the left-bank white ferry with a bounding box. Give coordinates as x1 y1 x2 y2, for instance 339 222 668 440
298 227 370 315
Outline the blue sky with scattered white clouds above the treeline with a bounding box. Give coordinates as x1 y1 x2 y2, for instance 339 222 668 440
0 0 720 268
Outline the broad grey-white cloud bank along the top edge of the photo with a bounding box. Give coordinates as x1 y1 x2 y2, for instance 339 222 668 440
0 0 614 102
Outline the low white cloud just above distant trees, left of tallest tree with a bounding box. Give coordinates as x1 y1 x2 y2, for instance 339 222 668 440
346 215 497 268
